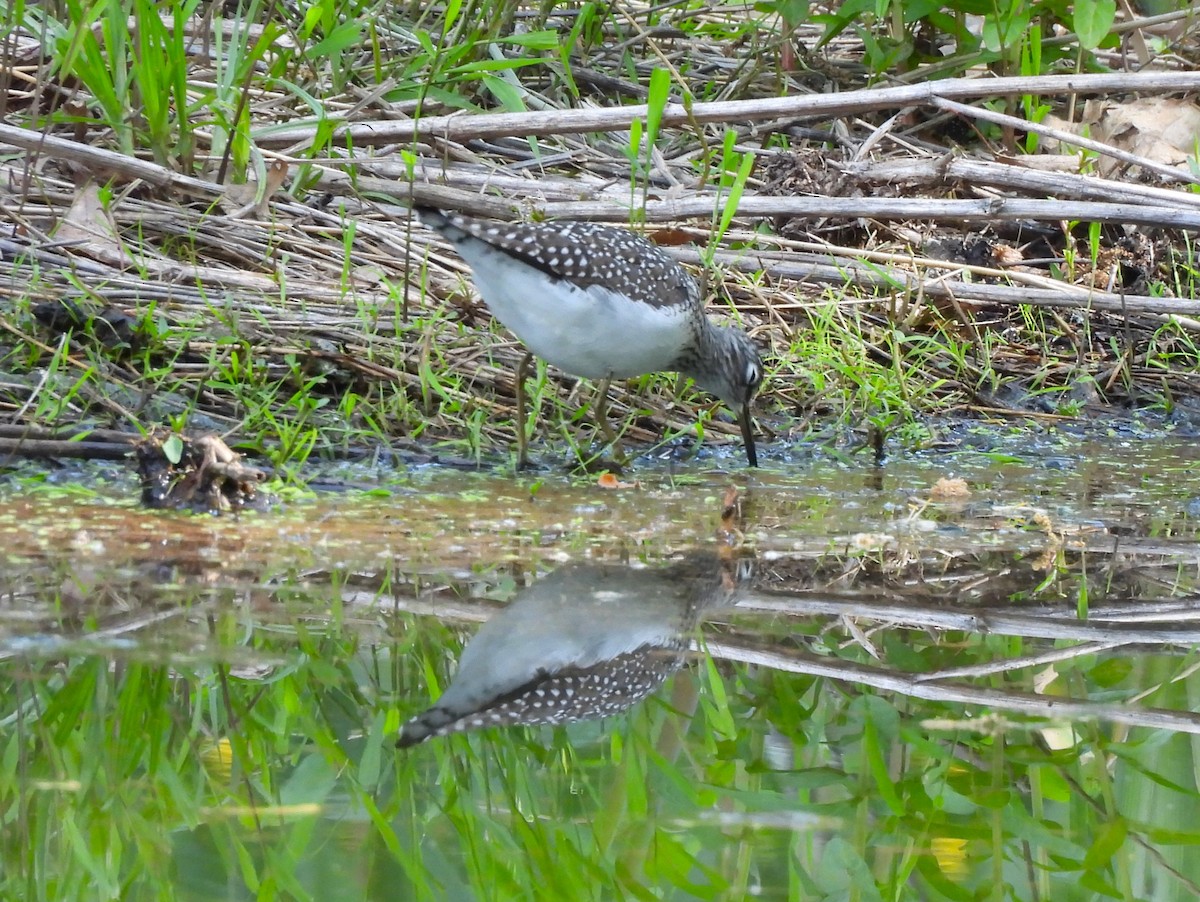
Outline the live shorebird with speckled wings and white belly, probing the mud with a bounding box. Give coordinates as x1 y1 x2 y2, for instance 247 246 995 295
415 206 763 467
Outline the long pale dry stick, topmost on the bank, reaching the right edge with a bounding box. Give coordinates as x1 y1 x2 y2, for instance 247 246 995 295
255 72 1200 154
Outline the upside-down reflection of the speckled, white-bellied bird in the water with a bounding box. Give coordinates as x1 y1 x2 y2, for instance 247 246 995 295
397 546 750 747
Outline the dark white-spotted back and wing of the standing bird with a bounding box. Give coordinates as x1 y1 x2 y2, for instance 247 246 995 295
418 208 701 308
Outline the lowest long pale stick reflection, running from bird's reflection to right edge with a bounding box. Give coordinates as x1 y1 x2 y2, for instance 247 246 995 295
706 641 1200 733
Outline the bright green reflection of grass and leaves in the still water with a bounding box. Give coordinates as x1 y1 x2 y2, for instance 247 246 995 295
9 618 1200 900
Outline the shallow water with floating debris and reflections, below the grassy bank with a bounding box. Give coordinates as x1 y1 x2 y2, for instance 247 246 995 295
0 431 1200 900
